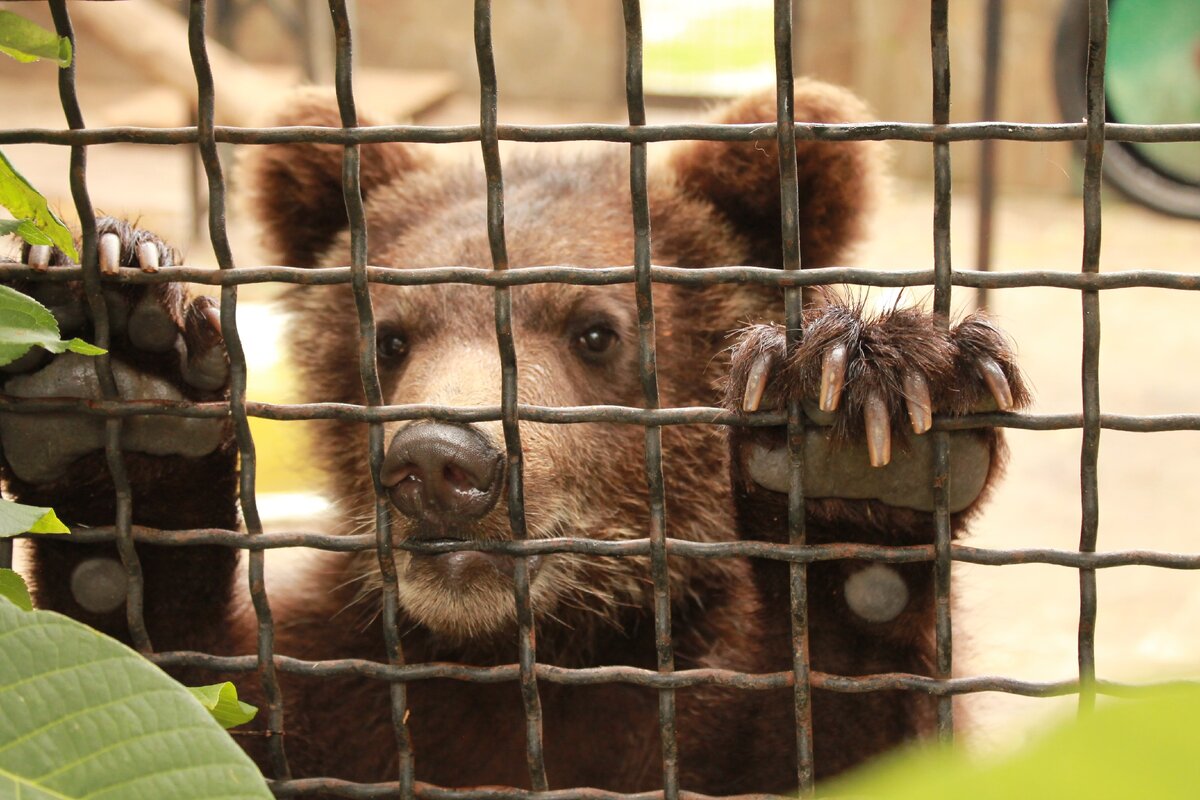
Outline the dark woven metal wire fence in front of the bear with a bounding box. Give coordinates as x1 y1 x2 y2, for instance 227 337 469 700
0 0 1200 800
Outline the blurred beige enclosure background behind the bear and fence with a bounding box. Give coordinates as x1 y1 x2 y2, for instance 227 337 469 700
0 0 1200 762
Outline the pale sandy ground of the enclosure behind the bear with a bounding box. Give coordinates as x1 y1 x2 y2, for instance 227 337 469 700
0 71 1200 746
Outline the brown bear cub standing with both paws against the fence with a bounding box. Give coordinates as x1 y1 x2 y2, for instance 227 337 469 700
0 77 1026 794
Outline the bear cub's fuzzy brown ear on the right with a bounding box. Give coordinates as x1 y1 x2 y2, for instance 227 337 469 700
671 80 884 266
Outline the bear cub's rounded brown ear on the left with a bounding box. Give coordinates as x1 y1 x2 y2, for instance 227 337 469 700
245 88 424 266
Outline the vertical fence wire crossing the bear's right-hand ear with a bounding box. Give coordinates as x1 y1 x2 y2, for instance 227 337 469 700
774 0 814 795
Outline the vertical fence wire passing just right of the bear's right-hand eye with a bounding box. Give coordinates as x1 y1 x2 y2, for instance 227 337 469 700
624 0 679 800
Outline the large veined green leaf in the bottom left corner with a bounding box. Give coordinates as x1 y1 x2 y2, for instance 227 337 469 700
0 601 271 800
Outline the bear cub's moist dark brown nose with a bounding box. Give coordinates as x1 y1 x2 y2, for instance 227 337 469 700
379 422 504 524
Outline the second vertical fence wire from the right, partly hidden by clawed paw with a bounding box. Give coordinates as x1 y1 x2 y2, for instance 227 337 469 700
930 0 954 741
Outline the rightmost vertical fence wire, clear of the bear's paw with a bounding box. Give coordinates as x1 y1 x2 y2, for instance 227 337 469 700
1079 0 1109 714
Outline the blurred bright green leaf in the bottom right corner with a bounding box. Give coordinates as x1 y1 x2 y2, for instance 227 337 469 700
818 685 1200 800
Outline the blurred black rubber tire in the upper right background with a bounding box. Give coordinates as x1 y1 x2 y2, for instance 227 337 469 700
1054 0 1200 219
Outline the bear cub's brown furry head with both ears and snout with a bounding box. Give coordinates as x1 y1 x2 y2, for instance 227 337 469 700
248 83 878 639
